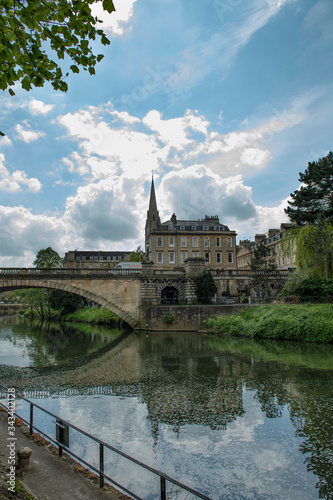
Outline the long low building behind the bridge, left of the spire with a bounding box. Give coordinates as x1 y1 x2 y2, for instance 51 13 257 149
64 250 131 269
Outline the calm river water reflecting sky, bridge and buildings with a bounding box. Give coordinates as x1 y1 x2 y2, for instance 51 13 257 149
0 316 333 500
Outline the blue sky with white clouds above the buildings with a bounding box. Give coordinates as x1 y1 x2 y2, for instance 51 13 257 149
0 0 333 267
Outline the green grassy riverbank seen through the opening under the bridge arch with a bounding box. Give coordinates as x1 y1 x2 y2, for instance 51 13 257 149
24 307 123 326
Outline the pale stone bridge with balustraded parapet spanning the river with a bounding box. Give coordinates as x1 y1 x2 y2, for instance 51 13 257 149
0 259 288 329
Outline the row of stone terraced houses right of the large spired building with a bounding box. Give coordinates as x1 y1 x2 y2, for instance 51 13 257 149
237 224 296 270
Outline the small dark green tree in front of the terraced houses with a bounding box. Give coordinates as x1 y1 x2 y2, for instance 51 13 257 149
250 245 277 297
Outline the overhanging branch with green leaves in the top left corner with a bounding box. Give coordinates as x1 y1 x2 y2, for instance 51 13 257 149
0 0 115 95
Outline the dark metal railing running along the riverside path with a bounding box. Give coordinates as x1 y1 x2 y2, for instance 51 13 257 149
0 386 212 500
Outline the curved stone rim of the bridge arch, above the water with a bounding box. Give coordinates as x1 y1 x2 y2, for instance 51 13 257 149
0 279 138 328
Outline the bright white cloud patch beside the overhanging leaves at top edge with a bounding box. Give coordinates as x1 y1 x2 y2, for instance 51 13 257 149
91 0 136 35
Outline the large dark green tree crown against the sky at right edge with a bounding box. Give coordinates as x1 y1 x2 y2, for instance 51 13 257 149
285 151 333 226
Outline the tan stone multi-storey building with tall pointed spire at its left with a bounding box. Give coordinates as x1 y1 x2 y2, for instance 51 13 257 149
145 180 236 269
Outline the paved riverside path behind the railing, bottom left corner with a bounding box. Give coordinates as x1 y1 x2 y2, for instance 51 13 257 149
0 411 129 500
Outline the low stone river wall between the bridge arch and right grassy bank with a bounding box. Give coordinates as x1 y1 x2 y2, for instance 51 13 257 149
136 304 248 332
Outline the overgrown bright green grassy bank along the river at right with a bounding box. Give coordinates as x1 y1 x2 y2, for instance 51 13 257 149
204 304 333 343
